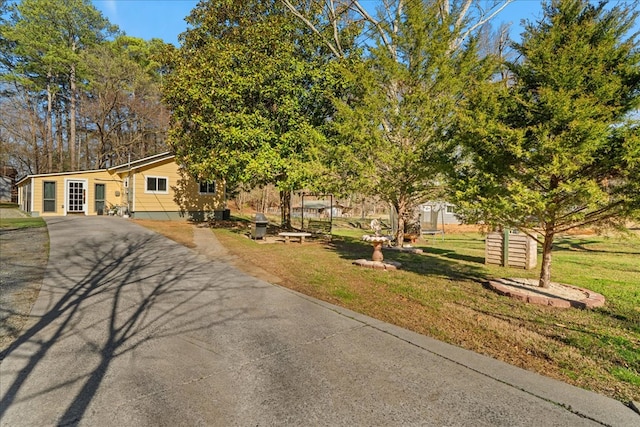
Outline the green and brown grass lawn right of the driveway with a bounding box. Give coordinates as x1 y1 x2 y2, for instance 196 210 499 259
215 229 640 402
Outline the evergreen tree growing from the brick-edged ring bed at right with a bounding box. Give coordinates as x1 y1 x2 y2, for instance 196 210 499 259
454 0 640 287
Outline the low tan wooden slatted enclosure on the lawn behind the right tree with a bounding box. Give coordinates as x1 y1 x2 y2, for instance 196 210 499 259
484 231 538 270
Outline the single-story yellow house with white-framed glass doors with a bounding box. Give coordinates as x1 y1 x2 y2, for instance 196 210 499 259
16 153 228 221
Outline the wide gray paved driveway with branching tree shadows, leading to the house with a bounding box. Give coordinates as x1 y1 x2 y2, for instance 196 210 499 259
0 217 640 426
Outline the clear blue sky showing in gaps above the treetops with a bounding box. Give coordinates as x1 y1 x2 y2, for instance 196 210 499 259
93 0 541 46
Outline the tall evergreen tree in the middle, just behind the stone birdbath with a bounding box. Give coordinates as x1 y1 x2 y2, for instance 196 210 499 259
320 1 488 246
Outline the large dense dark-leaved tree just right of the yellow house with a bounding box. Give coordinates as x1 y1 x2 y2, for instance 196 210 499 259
164 0 332 227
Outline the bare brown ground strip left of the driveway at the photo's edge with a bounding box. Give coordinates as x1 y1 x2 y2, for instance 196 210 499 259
0 227 49 352
